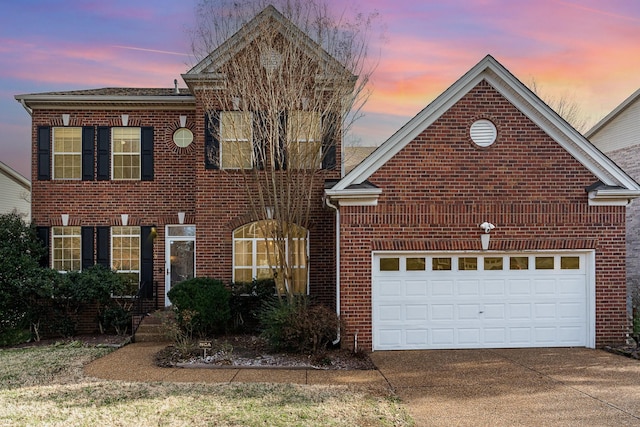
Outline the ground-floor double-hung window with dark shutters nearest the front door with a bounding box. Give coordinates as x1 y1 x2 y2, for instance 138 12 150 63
111 226 140 296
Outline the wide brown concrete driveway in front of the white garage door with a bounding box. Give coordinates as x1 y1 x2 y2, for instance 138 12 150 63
371 348 640 426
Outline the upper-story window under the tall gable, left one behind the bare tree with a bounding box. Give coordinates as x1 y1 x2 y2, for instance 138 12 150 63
220 111 253 169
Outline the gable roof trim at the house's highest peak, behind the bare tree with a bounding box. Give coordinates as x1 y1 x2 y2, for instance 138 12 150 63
182 5 347 79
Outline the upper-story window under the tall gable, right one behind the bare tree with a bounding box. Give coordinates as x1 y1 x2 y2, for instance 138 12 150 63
287 111 322 169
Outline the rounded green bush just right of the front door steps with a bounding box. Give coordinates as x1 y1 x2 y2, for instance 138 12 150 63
168 277 231 336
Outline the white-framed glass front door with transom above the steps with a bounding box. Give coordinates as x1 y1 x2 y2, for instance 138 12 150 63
164 225 196 307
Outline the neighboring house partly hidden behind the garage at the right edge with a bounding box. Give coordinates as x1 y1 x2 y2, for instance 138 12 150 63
585 89 640 310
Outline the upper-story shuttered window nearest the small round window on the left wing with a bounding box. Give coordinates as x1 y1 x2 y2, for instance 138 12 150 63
111 127 141 180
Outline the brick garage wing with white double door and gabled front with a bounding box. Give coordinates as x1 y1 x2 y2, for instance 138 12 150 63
326 56 640 350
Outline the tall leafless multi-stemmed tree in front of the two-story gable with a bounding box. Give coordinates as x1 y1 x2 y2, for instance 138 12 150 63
185 0 376 296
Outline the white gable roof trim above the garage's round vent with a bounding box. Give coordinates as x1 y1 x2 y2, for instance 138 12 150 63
326 55 640 204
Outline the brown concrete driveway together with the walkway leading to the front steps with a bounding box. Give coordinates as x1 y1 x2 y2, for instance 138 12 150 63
85 343 640 426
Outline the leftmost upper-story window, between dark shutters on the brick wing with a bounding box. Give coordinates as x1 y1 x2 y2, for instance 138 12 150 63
53 127 82 179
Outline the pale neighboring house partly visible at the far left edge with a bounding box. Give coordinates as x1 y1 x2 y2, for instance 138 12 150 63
0 162 31 222
